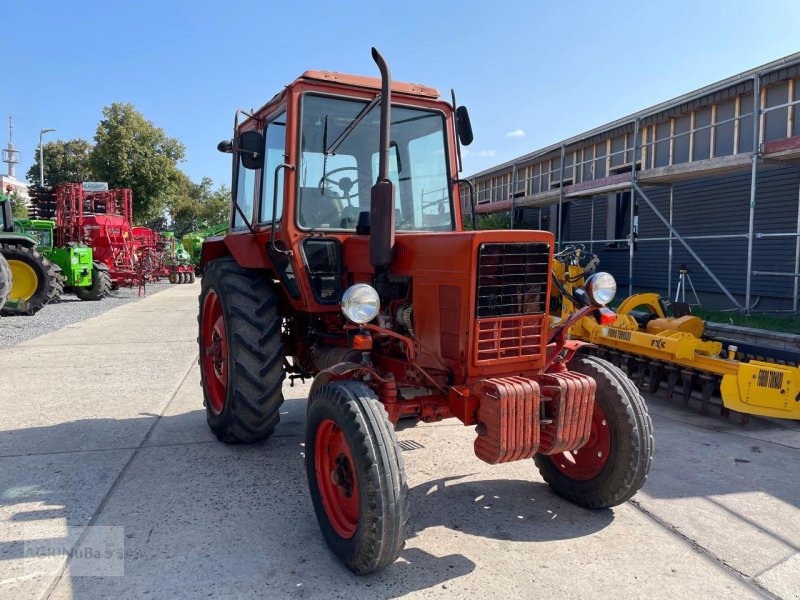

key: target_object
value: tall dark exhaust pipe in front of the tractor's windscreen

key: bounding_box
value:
[369,48,395,278]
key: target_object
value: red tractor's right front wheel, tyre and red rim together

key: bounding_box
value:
[534,356,653,508]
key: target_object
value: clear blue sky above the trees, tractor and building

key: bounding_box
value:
[0,0,800,185]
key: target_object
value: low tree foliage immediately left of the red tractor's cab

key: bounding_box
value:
[167,176,231,236]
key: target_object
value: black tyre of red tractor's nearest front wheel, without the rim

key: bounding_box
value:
[304,382,408,575]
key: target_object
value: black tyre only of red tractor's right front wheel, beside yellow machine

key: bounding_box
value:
[534,355,654,508]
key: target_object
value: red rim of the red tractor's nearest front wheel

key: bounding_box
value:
[314,419,358,538]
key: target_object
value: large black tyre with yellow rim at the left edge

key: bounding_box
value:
[0,244,64,315]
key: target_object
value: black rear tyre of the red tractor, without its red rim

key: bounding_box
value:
[197,257,285,444]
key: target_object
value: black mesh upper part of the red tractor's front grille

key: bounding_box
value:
[475,242,550,319]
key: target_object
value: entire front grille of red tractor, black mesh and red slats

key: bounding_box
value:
[475,242,550,364]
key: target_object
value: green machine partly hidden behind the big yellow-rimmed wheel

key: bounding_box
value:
[14,219,104,300]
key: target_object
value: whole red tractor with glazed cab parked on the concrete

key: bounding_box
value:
[198,49,653,573]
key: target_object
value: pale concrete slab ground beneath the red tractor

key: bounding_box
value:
[0,284,800,600]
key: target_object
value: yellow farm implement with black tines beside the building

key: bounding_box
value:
[551,247,800,419]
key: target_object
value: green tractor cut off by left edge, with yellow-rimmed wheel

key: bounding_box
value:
[0,194,64,315]
